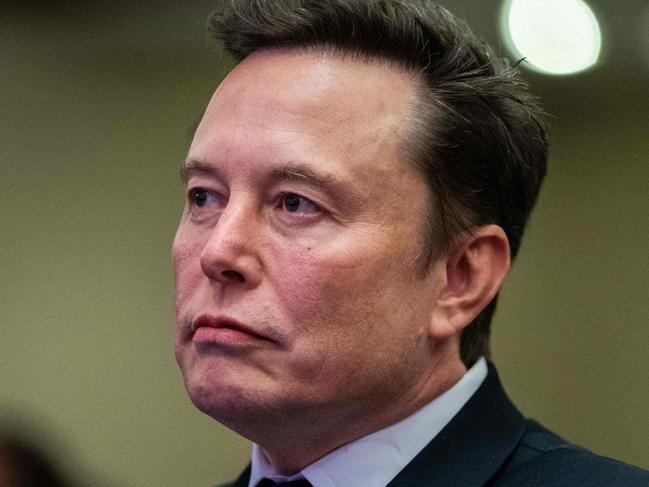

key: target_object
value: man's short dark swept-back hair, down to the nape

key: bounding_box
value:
[208,0,547,366]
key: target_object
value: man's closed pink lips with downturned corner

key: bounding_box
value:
[191,315,273,345]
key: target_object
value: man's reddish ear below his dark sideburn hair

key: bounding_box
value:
[431,225,510,340]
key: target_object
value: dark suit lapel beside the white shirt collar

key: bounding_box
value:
[388,363,525,487]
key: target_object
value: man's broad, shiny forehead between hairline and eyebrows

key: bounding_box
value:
[190,50,416,175]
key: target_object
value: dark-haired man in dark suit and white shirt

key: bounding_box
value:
[173,0,649,487]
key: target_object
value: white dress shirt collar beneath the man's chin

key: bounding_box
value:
[248,358,487,487]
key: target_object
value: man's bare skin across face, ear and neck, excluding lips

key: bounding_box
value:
[173,50,509,473]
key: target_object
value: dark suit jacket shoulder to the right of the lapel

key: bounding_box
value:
[493,421,649,487]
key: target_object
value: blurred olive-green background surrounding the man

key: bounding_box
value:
[0,0,649,487]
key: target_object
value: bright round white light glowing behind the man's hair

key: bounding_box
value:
[502,0,602,75]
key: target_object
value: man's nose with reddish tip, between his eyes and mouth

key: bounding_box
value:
[200,199,261,288]
